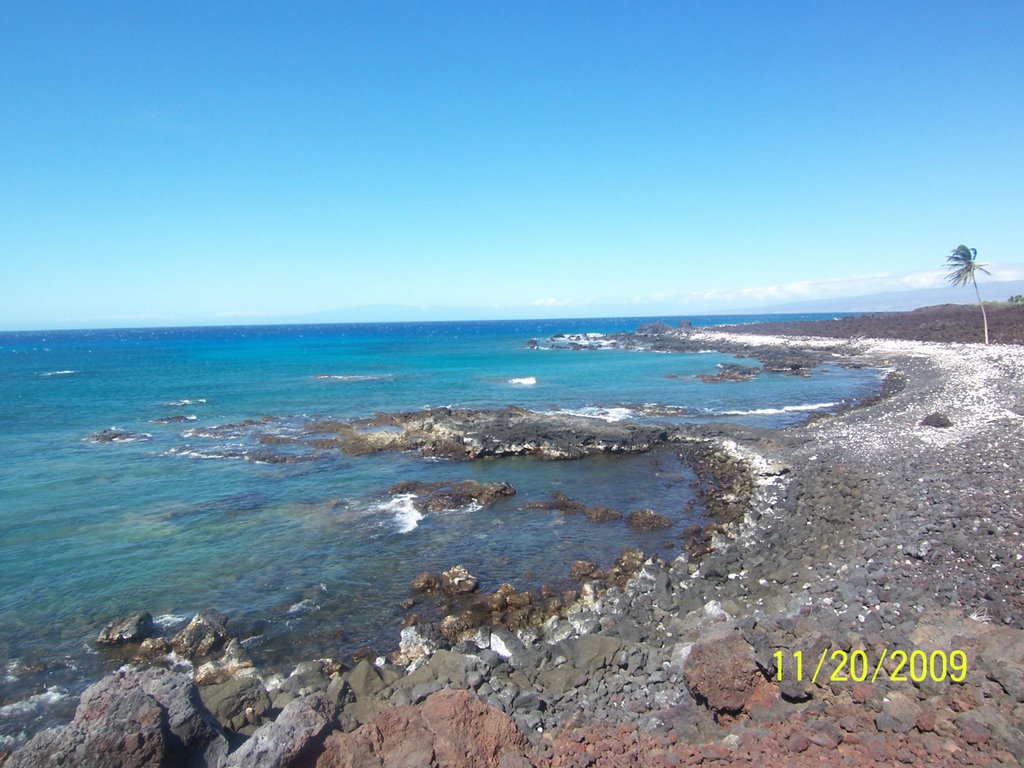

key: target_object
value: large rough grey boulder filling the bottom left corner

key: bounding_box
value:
[7,668,227,768]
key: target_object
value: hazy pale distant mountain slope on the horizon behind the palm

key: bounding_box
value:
[743,280,1024,313]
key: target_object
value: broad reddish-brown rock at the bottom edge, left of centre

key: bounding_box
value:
[316,690,529,768]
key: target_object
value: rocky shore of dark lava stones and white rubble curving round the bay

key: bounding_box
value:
[0,305,1024,768]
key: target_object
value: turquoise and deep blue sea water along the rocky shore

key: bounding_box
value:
[0,318,879,746]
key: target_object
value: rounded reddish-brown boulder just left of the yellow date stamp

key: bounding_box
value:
[683,627,764,713]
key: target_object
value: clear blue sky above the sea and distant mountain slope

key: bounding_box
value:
[0,0,1024,330]
